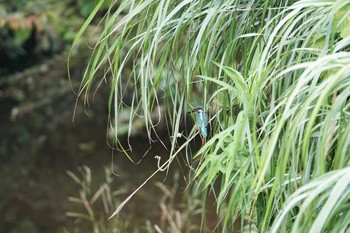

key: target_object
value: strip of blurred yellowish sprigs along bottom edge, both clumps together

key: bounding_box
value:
[65,166,208,233]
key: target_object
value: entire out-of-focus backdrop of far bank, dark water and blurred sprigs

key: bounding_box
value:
[0,0,215,233]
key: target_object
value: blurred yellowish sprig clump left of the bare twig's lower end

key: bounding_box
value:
[66,166,130,233]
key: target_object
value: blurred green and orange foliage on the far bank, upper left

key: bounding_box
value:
[0,0,111,65]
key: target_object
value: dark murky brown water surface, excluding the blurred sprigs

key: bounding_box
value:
[0,55,219,233]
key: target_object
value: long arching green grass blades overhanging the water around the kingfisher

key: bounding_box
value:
[75,0,350,232]
